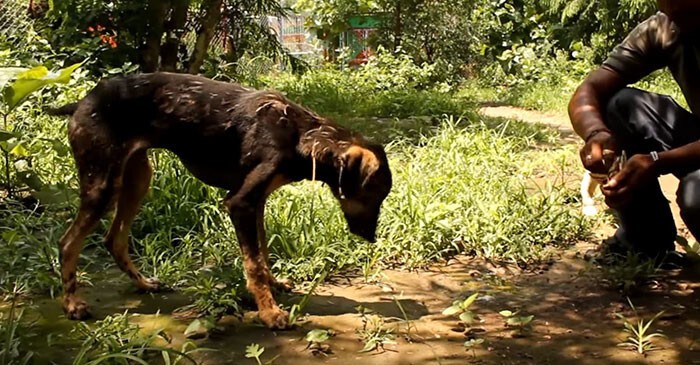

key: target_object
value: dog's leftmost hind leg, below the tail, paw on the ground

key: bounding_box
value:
[59,168,114,319]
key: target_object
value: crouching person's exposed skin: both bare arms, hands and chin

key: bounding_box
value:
[569,0,700,209]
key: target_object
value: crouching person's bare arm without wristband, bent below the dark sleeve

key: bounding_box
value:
[569,66,628,173]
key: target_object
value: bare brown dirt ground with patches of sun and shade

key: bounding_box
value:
[19,107,700,365]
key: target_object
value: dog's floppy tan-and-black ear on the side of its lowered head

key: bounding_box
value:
[340,145,380,197]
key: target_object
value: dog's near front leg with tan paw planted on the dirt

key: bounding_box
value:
[225,165,289,329]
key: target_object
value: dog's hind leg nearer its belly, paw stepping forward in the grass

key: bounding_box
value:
[105,149,159,291]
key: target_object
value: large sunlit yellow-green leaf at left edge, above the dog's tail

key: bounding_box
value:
[3,63,81,110]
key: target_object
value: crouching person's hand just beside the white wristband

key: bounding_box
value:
[601,155,656,209]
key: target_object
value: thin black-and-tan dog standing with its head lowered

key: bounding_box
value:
[48,73,392,328]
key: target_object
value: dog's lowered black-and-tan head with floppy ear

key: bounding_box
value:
[334,144,391,242]
